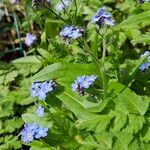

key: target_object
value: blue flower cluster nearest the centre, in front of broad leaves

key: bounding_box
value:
[71,75,97,96]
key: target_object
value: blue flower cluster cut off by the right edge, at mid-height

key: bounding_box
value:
[139,51,150,72]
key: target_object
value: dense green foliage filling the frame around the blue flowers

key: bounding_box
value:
[0,0,150,150]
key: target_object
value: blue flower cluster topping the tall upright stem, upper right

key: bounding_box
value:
[92,7,114,27]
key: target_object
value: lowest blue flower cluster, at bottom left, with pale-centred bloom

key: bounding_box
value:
[21,123,48,143]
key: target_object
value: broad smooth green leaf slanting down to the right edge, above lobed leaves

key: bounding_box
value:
[110,82,149,115]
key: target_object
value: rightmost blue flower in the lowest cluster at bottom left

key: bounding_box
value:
[35,126,48,139]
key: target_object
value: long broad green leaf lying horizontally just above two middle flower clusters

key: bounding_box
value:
[32,63,99,85]
